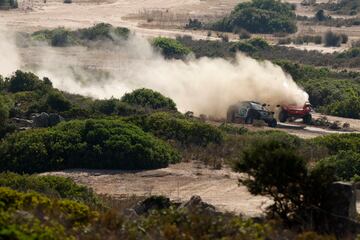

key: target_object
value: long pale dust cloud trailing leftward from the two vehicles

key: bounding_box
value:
[0,28,308,117]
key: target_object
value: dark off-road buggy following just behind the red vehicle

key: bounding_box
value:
[227,101,277,127]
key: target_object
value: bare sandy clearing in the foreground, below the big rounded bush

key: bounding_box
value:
[46,163,271,216]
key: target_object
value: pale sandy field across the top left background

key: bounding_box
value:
[0,0,239,37]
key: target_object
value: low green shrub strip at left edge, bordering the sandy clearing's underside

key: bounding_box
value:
[0,172,102,207]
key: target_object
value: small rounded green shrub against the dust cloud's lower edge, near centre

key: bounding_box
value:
[121,88,177,111]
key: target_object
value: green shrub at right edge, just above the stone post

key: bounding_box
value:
[316,151,360,181]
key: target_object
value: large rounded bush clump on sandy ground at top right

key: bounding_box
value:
[211,0,297,33]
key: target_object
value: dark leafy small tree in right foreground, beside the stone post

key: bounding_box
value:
[235,140,307,223]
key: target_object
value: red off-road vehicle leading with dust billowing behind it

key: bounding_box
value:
[279,102,312,124]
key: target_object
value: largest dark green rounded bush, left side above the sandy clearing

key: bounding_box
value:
[0,120,179,172]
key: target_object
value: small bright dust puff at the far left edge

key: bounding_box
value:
[0,26,20,75]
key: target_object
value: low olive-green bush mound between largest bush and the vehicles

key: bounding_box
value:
[126,112,223,146]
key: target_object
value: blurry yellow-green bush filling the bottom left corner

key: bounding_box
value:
[0,187,98,239]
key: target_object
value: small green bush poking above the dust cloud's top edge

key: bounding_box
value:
[152,37,191,59]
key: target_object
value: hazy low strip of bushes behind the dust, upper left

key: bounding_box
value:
[31,23,130,47]
